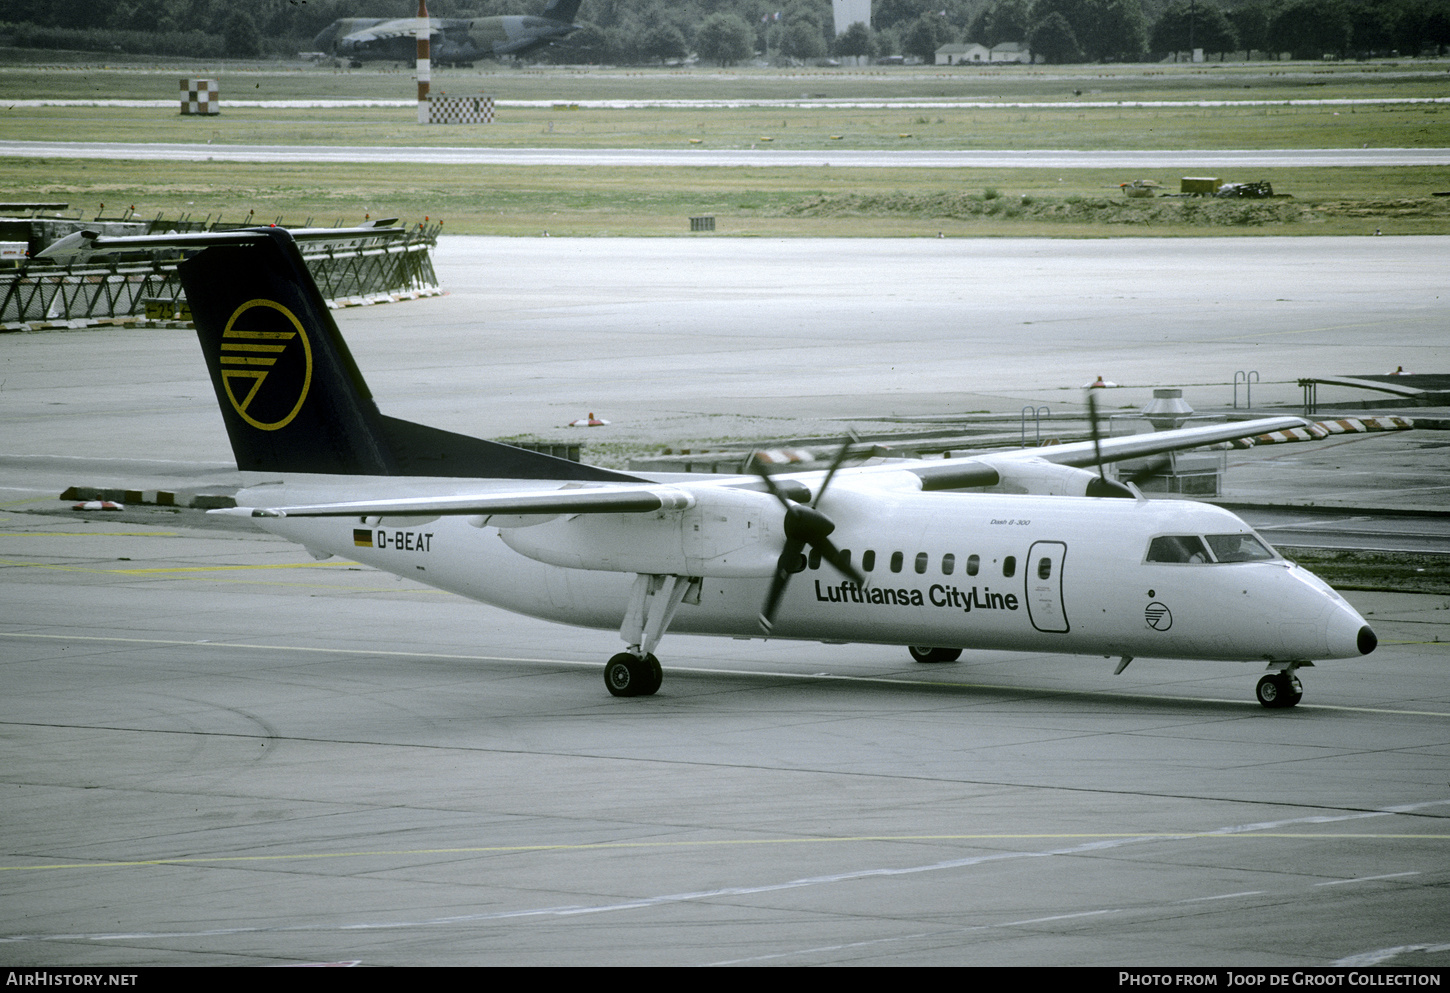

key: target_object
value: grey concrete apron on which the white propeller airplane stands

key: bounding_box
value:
[0,238,1450,968]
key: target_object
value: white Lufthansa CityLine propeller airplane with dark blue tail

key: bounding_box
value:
[113,228,1376,707]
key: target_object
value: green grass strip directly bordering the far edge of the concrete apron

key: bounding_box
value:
[0,158,1450,238]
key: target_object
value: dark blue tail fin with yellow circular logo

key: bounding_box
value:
[178,228,635,481]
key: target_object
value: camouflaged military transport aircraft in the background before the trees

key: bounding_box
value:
[312,0,580,65]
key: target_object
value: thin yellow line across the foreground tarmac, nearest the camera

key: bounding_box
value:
[0,831,1450,873]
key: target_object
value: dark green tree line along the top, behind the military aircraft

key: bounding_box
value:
[0,0,1450,65]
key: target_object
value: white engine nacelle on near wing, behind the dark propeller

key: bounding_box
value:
[499,487,784,578]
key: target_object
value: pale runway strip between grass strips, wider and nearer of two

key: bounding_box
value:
[0,141,1450,170]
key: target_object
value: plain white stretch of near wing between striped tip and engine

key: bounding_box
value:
[226,484,695,518]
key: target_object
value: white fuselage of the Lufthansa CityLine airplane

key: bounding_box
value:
[239,477,1366,661]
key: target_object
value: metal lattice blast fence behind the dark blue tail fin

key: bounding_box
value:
[0,225,439,325]
